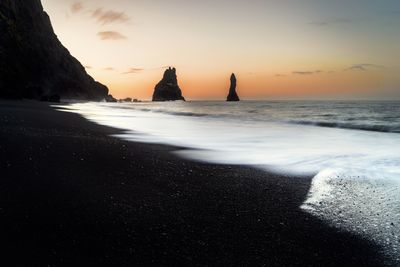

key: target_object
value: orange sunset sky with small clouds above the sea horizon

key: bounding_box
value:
[42,0,400,100]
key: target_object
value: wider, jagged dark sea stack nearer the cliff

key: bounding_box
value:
[153,67,185,101]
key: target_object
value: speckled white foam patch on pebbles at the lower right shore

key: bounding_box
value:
[301,170,400,264]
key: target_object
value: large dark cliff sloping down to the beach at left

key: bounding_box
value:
[0,0,108,101]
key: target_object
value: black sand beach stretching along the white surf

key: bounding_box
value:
[0,101,384,266]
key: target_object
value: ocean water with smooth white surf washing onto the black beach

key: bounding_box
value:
[57,101,400,264]
